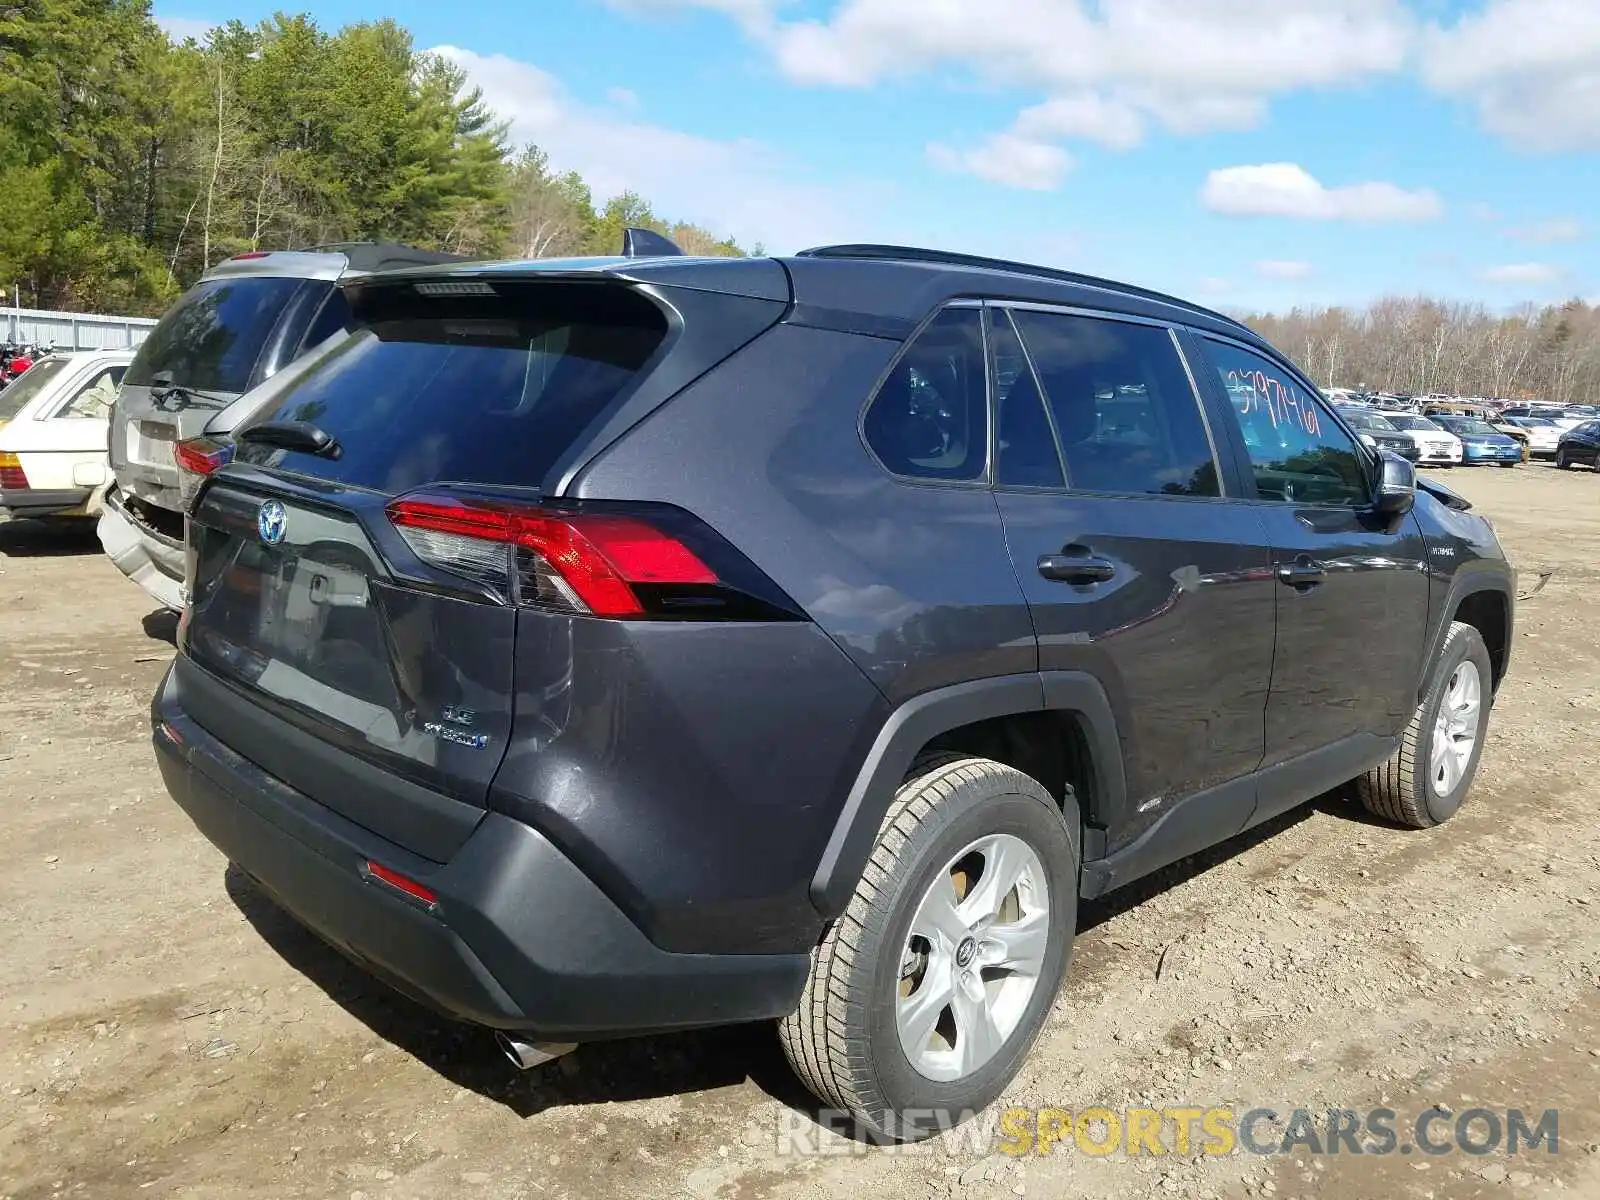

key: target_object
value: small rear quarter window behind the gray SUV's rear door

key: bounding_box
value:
[862,309,989,480]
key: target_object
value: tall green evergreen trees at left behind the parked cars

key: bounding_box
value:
[0,0,744,314]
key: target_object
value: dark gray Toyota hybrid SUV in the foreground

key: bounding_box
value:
[154,246,1512,1138]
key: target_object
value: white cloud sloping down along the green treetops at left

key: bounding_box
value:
[434,46,896,253]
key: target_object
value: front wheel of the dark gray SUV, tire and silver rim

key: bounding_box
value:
[1355,621,1494,829]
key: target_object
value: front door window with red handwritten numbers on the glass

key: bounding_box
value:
[1206,338,1368,506]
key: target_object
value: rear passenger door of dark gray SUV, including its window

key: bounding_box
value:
[989,306,1274,858]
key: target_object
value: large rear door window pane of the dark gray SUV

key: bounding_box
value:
[1013,310,1222,496]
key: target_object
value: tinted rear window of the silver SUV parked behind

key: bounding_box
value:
[125,275,304,392]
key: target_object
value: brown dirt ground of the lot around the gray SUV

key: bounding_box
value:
[0,466,1600,1200]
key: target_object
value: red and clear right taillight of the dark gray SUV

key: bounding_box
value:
[387,494,723,618]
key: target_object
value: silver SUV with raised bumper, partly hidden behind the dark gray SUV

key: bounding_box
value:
[99,242,461,610]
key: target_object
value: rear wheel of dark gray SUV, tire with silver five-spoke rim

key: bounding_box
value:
[779,755,1080,1141]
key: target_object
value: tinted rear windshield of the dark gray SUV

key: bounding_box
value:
[238,283,667,494]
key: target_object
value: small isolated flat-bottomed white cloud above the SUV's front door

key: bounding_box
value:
[1200,163,1445,222]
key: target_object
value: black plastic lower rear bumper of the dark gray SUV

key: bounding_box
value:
[152,674,810,1042]
